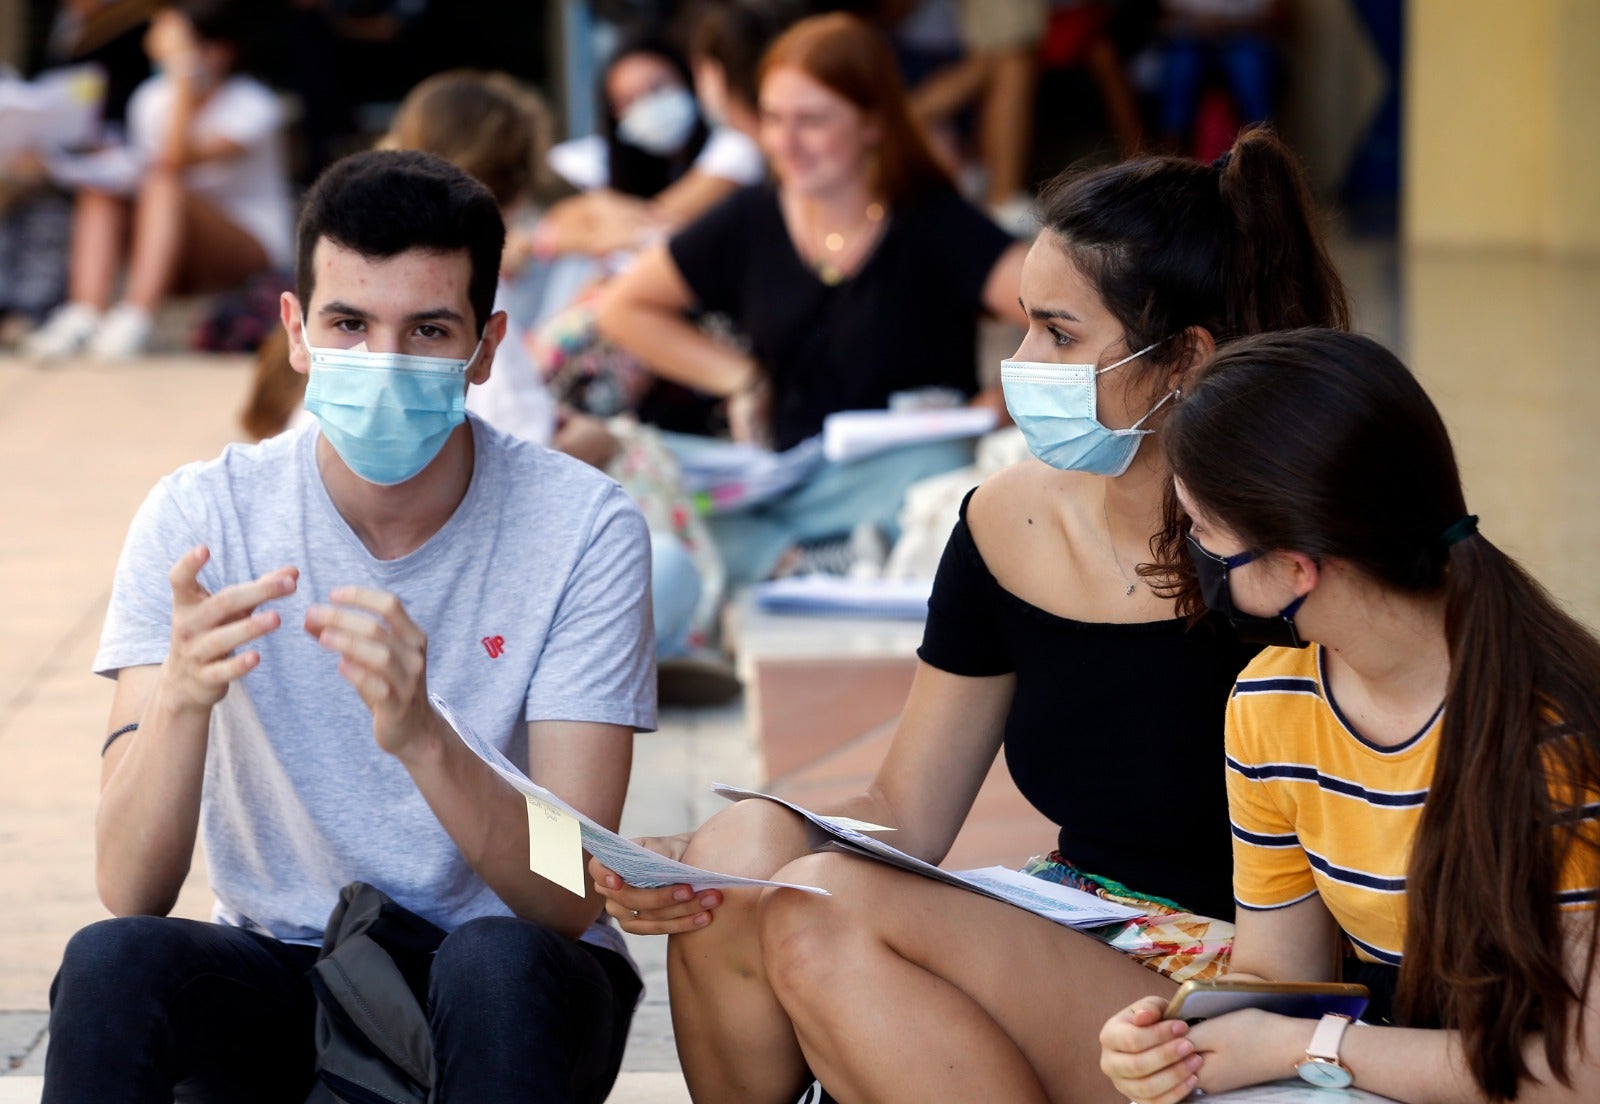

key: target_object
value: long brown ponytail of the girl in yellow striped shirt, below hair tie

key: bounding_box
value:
[1397,536,1600,1099]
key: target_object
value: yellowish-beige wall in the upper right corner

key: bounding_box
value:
[1402,0,1600,254]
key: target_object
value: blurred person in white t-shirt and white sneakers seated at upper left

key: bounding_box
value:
[24,0,294,358]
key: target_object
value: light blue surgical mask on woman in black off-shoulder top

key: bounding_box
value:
[1000,341,1178,475]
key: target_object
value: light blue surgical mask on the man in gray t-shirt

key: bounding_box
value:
[302,323,483,486]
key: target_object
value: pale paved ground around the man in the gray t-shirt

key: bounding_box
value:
[0,357,748,1104]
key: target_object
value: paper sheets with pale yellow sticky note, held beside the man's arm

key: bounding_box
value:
[441,694,827,896]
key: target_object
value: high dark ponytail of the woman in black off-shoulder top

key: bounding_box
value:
[1213,126,1350,334]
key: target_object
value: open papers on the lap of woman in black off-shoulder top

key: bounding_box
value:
[712,786,1144,928]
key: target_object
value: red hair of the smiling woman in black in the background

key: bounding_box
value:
[760,11,950,203]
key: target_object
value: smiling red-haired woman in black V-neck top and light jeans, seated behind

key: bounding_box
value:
[598,13,1024,582]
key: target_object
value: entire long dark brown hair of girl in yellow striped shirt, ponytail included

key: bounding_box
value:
[1154,330,1600,1099]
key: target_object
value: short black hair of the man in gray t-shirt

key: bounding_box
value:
[294,149,506,333]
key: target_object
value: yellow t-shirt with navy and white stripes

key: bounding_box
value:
[1226,645,1597,965]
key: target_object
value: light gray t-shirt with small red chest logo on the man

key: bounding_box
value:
[94,416,656,947]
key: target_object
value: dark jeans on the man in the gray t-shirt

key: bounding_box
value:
[43,917,640,1104]
